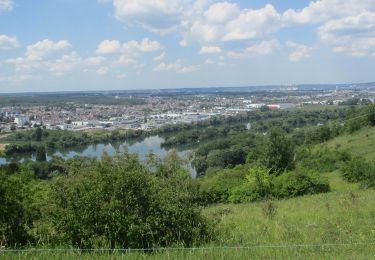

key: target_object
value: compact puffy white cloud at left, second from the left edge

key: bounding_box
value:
[25,39,72,61]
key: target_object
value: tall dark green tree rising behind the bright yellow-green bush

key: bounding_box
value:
[263,128,294,174]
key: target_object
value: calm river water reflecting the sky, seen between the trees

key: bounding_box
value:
[0,136,196,177]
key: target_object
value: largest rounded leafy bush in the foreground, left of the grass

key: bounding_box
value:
[46,154,209,248]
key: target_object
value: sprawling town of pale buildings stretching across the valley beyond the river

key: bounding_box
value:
[0,84,375,132]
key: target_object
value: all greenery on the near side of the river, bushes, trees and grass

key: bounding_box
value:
[0,106,375,259]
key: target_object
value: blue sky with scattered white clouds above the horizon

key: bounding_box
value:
[0,0,375,93]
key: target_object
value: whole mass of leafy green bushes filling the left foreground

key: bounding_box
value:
[0,153,213,248]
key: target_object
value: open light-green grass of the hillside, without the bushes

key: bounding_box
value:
[0,128,375,259]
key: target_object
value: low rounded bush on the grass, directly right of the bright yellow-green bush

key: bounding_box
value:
[273,169,330,198]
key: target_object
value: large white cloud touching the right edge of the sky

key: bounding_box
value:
[319,11,375,56]
